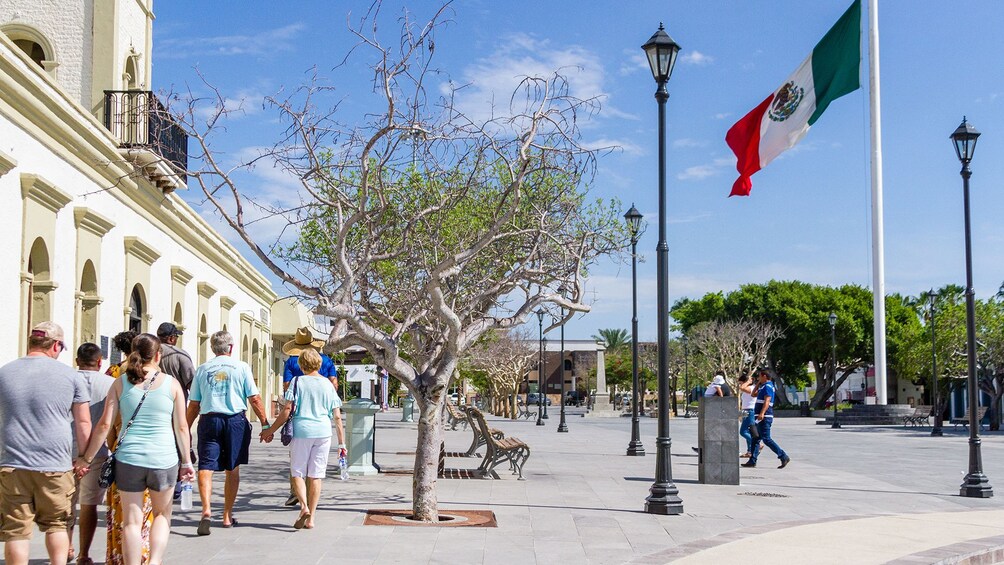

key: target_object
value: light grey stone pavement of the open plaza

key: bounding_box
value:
[5,406,1004,565]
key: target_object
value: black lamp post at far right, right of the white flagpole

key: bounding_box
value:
[952,116,994,499]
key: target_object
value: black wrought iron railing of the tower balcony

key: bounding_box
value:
[104,90,188,183]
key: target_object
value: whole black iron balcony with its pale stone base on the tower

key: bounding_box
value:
[104,90,188,192]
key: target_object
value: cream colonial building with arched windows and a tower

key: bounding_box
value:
[0,0,277,411]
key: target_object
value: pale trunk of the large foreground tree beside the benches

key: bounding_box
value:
[412,394,446,523]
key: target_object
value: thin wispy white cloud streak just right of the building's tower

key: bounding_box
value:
[156,23,306,59]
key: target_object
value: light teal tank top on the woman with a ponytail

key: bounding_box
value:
[115,372,179,469]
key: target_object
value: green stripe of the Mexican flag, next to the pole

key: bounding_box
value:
[809,0,861,125]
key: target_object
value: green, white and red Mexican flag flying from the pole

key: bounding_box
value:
[725,0,861,197]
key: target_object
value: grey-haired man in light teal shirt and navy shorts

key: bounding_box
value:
[188,331,268,536]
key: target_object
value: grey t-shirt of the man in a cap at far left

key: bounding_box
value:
[0,356,90,473]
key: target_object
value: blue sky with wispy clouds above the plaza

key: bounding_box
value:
[153,0,1004,340]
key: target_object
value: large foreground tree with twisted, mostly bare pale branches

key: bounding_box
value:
[160,3,626,521]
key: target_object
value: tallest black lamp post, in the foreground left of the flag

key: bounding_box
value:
[642,24,684,515]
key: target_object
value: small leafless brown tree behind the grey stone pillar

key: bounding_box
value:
[688,318,784,390]
